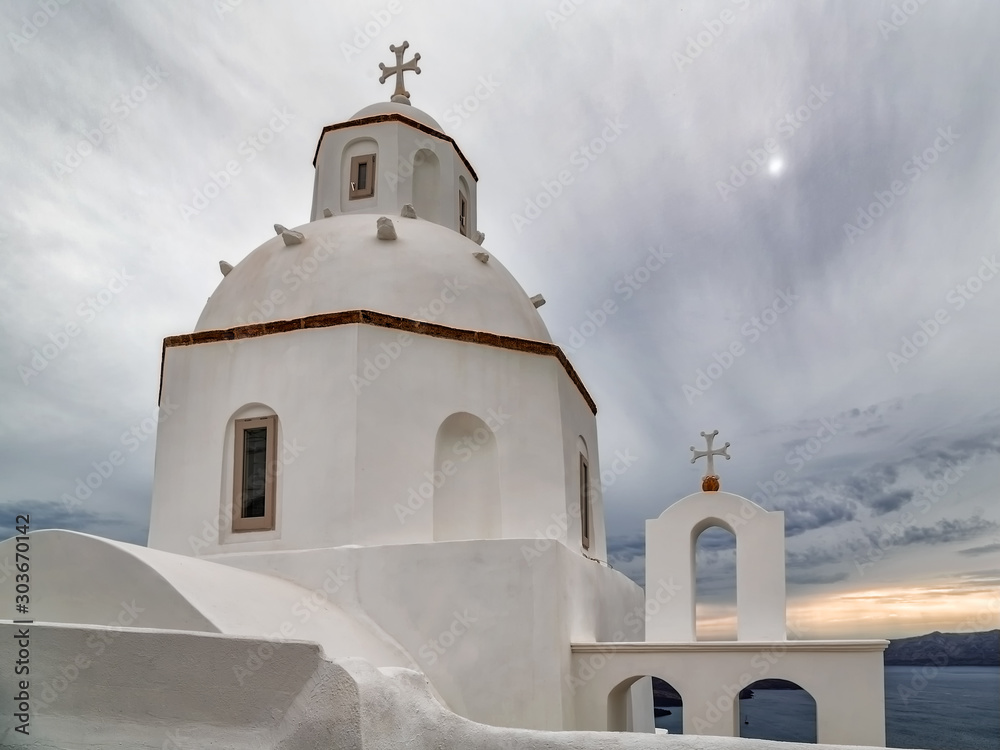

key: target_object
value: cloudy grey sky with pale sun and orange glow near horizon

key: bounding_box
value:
[0,0,1000,637]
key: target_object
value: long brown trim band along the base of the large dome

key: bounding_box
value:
[160,310,597,414]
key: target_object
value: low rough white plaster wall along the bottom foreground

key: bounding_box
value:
[0,623,892,750]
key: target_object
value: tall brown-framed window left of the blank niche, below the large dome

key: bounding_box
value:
[233,415,278,531]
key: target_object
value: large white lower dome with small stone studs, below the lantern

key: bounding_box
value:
[196,214,552,342]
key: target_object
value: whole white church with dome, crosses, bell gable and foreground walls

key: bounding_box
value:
[0,47,887,750]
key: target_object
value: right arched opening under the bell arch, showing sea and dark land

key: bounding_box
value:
[737,679,816,742]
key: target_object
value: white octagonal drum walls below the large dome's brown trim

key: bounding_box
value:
[149,325,605,556]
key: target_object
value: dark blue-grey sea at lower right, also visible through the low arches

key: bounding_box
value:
[656,667,1000,750]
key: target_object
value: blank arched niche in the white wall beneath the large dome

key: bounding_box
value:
[433,412,501,542]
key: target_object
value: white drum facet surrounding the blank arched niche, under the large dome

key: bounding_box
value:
[353,326,593,544]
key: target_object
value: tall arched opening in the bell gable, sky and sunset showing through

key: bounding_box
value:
[692,524,737,641]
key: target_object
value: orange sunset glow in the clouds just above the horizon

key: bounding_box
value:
[698,584,1000,640]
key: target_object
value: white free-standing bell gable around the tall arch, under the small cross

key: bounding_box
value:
[646,492,786,642]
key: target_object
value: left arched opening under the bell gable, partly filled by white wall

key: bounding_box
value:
[608,675,684,734]
